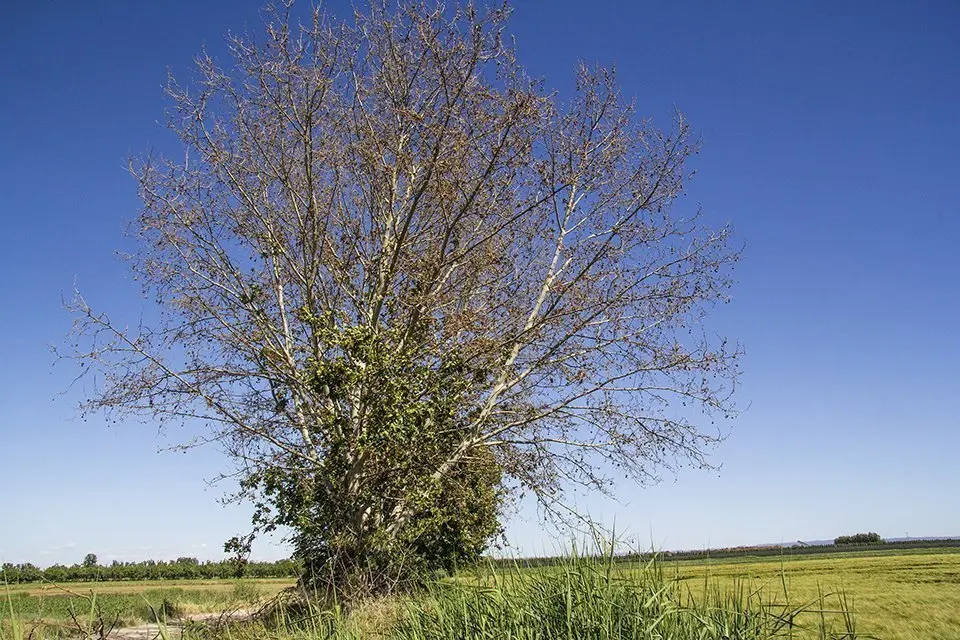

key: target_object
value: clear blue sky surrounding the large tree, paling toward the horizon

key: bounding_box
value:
[0,0,960,564]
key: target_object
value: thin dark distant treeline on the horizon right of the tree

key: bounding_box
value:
[491,538,960,567]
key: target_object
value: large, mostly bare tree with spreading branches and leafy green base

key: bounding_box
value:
[67,4,738,593]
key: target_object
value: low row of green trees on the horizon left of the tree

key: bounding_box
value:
[0,558,300,584]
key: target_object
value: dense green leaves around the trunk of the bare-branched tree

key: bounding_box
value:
[245,318,501,595]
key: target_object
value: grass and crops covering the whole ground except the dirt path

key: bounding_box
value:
[0,548,960,640]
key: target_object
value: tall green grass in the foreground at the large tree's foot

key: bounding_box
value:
[178,555,865,640]
